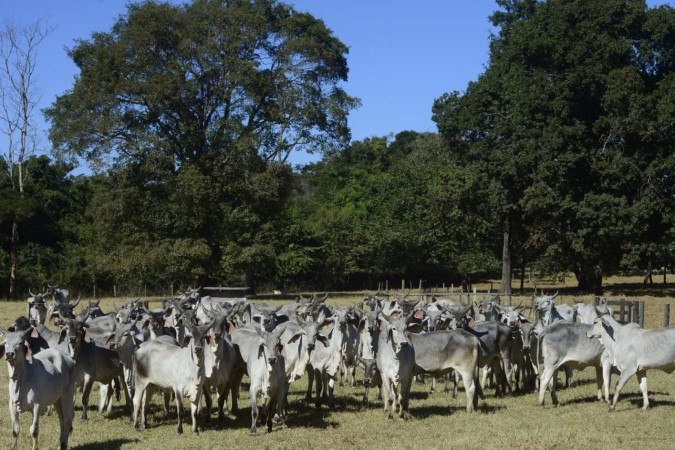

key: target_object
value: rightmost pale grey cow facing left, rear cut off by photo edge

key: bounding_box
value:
[587,315,675,410]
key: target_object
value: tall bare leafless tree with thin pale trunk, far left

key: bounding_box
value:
[0,21,51,298]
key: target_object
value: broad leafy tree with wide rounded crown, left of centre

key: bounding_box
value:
[46,0,357,283]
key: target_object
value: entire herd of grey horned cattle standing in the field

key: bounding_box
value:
[0,286,675,448]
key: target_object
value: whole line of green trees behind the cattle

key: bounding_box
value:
[0,0,675,294]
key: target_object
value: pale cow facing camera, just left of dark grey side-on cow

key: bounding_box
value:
[375,314,419,420]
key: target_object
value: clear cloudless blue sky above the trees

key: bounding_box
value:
[0,0,671,170]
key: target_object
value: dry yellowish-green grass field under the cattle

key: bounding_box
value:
[0,278,675,449]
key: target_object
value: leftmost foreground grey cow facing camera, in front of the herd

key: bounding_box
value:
[0,327,75,450]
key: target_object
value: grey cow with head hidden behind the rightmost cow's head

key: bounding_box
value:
[539,321,609,406]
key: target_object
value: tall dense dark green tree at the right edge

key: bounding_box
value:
[434,0,673,292]
